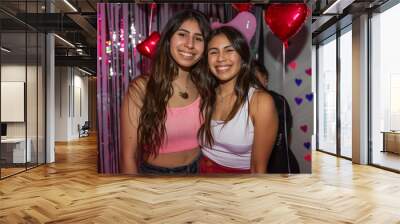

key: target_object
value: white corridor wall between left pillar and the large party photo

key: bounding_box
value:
[55,67,88,141]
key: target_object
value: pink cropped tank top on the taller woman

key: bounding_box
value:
[159,97,202,153]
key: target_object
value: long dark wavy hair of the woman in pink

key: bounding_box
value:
[136,9,210,164]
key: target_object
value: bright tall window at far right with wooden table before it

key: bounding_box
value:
[370,1,400,170]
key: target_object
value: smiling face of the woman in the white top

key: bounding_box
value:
[207,34,242,83]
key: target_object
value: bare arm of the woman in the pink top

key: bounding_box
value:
[120,77,145,174]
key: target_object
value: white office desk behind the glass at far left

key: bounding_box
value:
[1,138,32,163]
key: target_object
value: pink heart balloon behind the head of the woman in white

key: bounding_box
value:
[211,12,257,44]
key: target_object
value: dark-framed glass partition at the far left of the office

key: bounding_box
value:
[0,1,46,178]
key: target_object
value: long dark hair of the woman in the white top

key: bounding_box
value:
[198,26,265,147]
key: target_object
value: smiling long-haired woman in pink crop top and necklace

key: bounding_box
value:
[120,10,210,174]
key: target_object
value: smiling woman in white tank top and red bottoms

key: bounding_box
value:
[199,26,278,173]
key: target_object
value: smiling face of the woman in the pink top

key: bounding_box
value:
[170,19,204,70]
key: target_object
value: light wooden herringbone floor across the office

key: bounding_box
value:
[0,134,400,224]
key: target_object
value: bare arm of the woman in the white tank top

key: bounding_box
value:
[250,91,278,173]
